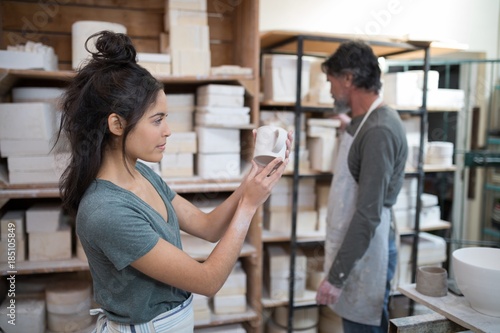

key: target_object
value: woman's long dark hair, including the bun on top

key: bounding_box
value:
[58,31,163,213]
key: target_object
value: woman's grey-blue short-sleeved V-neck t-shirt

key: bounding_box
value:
[76,162,190,324]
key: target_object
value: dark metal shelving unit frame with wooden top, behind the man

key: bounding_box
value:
[261,31,430,332]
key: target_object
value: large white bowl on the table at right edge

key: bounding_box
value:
[452,247,500,317]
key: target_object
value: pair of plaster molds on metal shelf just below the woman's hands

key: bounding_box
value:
[264,177,318,236]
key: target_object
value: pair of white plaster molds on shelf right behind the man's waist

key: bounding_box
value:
[392,178,441,230]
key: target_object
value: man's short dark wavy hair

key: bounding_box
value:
[321,41,382,92]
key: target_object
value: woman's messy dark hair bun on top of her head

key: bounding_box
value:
[85,30,137,64]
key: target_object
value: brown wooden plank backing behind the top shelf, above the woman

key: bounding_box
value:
[0,0,254,69]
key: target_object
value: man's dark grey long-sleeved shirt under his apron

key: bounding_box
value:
[328,106,408,287]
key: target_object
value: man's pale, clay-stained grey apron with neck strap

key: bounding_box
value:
[324,97,391,326]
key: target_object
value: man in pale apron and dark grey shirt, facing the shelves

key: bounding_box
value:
[316,41,408,333]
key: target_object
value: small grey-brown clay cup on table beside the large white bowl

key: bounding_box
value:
[416,266,448,297]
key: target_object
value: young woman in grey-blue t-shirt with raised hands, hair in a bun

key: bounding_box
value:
[60,31,292,333]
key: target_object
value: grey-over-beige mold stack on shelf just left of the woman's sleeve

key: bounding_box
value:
[26,203,72,261]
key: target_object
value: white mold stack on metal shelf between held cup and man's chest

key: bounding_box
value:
[307,118,340,172]
